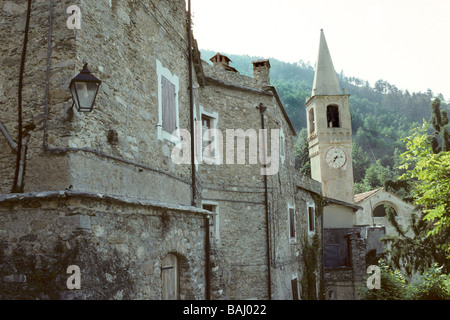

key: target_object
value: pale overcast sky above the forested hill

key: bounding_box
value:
[191,0,450,101]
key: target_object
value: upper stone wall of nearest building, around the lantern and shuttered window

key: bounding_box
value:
[0,0,191,204]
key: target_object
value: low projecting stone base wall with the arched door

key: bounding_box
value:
[0,192,205,300]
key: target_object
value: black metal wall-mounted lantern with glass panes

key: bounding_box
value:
[69,63,102,112]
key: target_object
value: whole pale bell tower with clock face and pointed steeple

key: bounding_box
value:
[305,30,354,204]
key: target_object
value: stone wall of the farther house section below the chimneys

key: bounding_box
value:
[195,56,321,299]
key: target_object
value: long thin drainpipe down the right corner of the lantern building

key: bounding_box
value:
[188,0,197,207]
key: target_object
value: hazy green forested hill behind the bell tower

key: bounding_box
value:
[201,50,450,191]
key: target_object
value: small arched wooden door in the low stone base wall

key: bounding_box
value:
[161,254,180,300]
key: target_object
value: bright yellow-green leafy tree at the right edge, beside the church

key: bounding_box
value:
[383,119,450,275]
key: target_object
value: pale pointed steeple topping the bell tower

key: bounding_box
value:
[312,29,342,96]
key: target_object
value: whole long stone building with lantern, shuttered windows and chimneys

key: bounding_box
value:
[0,0,323,300]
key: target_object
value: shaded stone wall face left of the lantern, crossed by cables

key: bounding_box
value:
[0,0,75,193]
